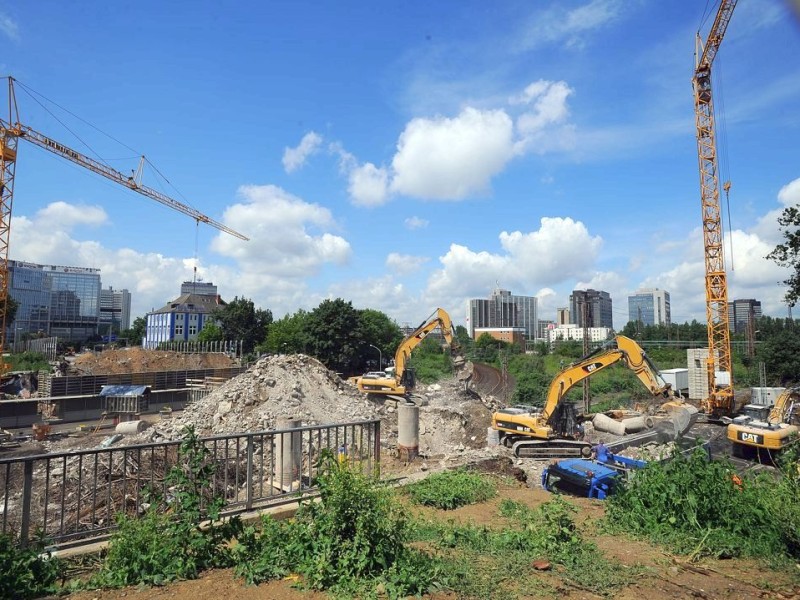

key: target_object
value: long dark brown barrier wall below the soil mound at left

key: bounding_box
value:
[39,366,247,398]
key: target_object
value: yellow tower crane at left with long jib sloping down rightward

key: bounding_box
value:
[0,77,248,374]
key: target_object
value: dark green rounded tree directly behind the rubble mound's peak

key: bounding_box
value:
[303,298,364,374]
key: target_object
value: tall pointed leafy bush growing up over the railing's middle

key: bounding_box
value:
[90,428,241,587]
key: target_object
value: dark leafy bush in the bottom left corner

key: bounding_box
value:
[0,535,63,600]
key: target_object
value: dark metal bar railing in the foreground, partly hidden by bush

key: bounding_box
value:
[0,420,381,547]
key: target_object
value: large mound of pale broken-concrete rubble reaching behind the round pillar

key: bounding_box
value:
[136,354,491,455]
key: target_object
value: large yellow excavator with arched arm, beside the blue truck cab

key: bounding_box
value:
[492,335,684,458]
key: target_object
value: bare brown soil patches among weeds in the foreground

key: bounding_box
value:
[68,474,800,600]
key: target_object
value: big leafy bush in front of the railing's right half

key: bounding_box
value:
[235,452,440,598]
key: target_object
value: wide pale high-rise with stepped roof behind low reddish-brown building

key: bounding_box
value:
[467,288,538,340]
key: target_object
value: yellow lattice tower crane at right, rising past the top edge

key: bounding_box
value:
[692,0,737,418]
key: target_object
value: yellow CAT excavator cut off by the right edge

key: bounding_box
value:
[728,386,800,461]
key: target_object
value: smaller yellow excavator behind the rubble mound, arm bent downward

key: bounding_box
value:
[355,308,464,400]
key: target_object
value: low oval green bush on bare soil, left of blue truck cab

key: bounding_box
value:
[406,469,497,510]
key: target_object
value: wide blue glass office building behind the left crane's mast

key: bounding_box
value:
[6,260,100,341]
